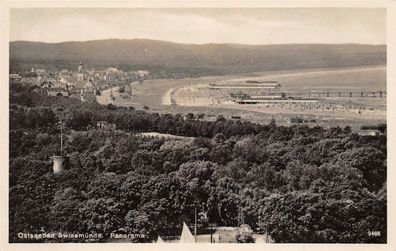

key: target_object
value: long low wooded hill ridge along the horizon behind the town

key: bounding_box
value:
[10,39,386,73]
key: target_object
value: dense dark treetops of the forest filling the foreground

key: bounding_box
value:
[9,86,387,243]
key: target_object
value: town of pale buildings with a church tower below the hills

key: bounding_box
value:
[10,63,149,101]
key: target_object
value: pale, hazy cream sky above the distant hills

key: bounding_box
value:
[10,8,386,44]
